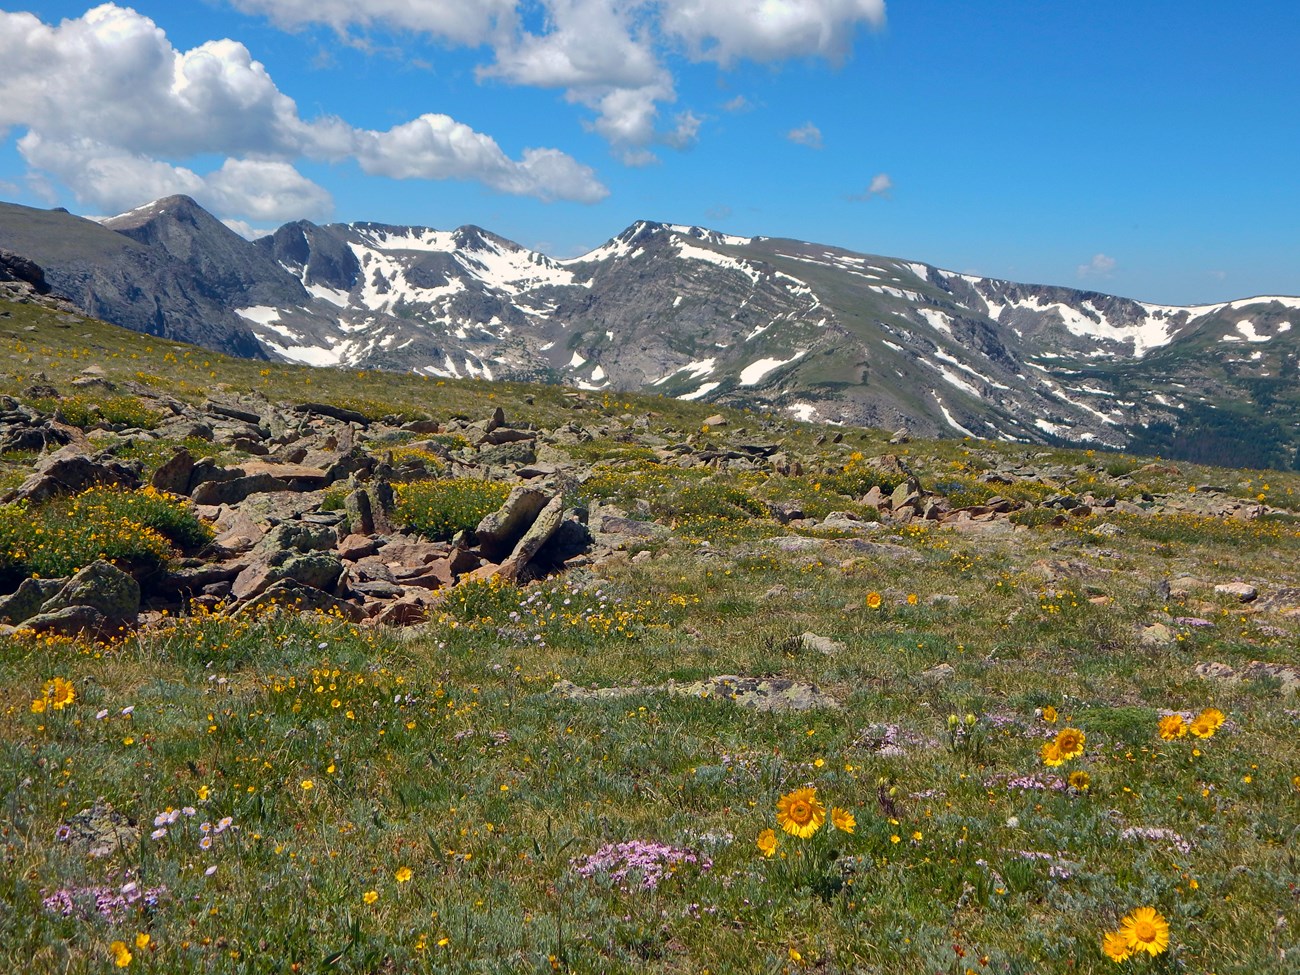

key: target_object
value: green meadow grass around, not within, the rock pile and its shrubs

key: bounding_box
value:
[0,301,1300,975]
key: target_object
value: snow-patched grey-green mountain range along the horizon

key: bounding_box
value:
[0,196,1300,468]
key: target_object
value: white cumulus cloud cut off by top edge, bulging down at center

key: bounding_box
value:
[231,0,885,165]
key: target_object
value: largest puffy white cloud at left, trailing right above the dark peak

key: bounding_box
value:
[0,3,606,220]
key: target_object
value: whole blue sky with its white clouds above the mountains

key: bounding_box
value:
[0,0,1300,304]
